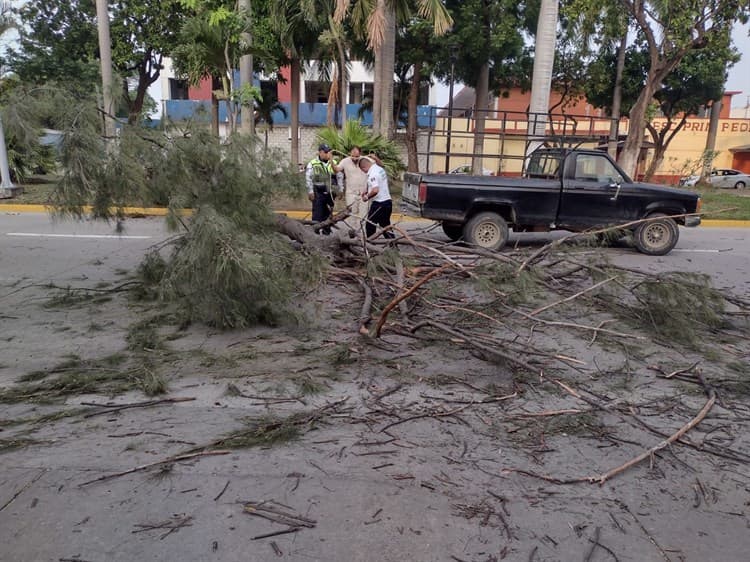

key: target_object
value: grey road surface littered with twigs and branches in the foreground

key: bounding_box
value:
[0,228,750,562]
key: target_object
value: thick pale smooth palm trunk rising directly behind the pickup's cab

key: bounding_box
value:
[526,0,558,156]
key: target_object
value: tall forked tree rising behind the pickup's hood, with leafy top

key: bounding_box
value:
[620,0,750,176]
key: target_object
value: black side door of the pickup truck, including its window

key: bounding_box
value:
[557,153,624,227]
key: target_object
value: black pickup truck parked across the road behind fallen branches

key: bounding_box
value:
[402,148,701,255]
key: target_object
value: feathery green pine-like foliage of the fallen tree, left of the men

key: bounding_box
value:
[50,103,322,328]
